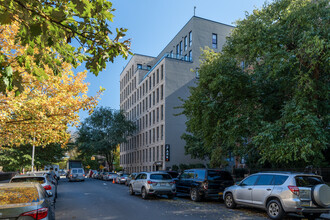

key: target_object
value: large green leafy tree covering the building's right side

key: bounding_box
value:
[182,0,330,166]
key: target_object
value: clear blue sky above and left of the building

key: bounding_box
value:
[76,0,265,125]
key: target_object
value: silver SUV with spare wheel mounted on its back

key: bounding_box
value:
[223,172,330,219]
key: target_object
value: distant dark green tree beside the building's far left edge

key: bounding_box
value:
[76,107,135,170]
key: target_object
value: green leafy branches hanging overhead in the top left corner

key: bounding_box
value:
[0,0,130,92]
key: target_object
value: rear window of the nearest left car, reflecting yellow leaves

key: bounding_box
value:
[0,187,39,206]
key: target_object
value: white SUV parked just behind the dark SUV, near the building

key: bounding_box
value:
[129,172,176,199]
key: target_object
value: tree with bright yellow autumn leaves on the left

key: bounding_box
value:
[0,24,101,146]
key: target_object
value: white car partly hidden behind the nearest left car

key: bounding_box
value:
[9,174,57,203]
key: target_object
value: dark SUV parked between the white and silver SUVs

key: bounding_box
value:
[176,169,234,202]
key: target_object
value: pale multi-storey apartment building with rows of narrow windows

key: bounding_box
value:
[120,16,233,172]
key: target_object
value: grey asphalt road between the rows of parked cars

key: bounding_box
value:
[56,179,328,220]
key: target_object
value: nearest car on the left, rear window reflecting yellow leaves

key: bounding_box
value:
[0,182,55,220]
